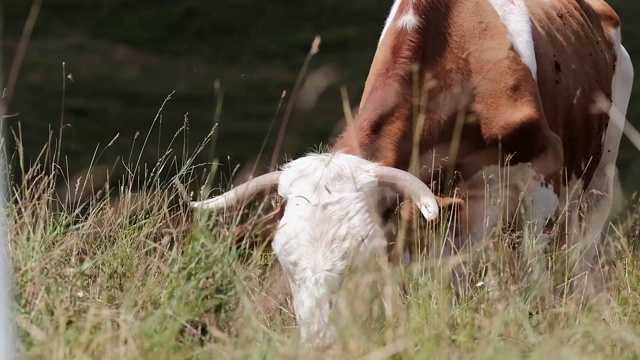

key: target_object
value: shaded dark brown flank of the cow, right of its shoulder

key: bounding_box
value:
[527,0,620,184]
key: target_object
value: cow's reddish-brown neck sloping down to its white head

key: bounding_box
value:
[333,0,450,168]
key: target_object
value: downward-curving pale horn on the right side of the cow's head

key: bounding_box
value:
[373,166,439,220]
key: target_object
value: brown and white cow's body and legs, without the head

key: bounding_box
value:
[334,0,633,288]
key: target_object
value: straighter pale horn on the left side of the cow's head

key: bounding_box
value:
[191,170,282,210]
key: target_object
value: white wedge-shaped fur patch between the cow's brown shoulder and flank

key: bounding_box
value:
[489,0,538,79]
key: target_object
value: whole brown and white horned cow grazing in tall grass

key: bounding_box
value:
[193,0,634,343]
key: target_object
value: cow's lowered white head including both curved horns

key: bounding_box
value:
[191,153,438,344]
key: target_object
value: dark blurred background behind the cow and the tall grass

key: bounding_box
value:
[2,0,640,198]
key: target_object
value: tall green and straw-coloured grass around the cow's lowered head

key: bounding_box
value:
[9,88,640,359]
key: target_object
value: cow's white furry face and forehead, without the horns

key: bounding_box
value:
[272,154,386,344]
